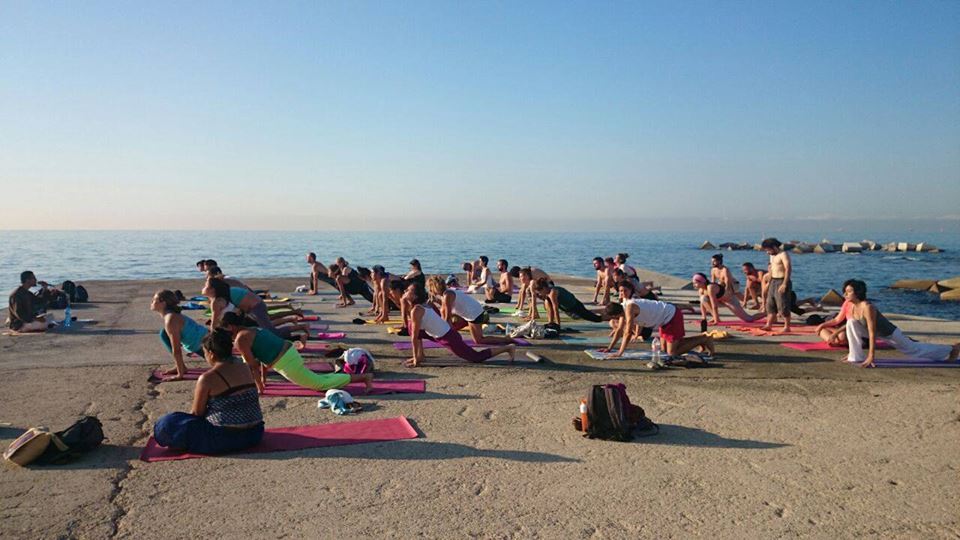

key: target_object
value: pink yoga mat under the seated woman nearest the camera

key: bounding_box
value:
[140,416,417,463]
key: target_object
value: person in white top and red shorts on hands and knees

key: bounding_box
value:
[600,282,716,358]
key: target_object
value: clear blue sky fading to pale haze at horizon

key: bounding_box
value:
[0,0,960,230]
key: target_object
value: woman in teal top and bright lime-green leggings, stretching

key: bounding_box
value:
[223,313,373,393]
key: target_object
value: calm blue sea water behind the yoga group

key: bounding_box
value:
[0,231,960,320]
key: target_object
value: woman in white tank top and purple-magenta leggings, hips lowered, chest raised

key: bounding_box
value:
[403,283,517,367]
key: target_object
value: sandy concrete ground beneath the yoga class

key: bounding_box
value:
[0,275,960,538]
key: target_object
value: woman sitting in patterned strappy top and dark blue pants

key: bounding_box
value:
[153,329,263,454]
